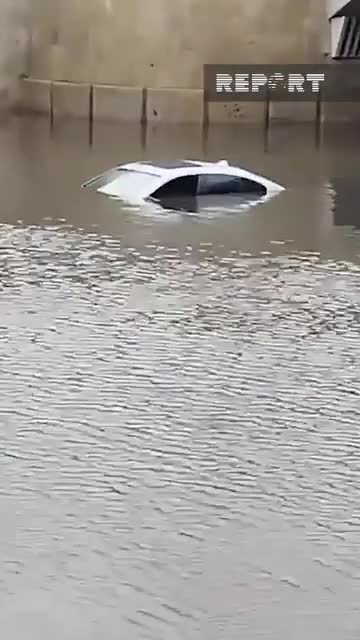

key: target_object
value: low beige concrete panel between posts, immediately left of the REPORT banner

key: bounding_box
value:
[146,89,204,124]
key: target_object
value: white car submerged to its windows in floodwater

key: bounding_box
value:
[82,160,284,210]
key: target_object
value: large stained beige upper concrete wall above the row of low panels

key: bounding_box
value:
[27,0,327,89]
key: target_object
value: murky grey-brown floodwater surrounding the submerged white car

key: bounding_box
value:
[0,119,360,640]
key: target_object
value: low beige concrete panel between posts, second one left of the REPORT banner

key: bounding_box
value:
[93,85,144,122]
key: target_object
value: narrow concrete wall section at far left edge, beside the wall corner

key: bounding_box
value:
[0,0,28,109]
